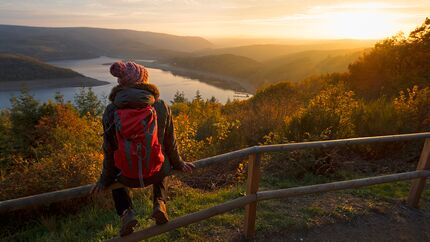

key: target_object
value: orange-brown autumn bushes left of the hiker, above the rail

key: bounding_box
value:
[0,95,103,200]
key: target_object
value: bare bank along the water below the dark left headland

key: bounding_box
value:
[0,76,110,92]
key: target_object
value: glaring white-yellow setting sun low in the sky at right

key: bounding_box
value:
[327,9,399,39]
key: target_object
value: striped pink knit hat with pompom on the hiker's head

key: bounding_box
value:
[110,61,148,85]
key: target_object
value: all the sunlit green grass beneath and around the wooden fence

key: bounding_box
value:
[0,172,430,242]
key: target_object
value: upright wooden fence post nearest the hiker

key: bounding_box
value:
[244,153,261,239]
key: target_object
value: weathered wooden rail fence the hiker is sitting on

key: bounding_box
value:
[0,132,430,242]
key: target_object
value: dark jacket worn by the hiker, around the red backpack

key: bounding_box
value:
[99,84,184,187]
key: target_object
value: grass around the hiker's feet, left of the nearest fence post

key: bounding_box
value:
[0,182,243,241]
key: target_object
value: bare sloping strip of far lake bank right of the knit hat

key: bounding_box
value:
[137,61,257,95]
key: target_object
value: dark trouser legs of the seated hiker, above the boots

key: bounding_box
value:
[112,178,167,216]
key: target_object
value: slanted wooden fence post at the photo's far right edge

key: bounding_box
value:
[408,139,430,208]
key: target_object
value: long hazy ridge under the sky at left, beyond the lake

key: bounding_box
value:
[0,25,213,60]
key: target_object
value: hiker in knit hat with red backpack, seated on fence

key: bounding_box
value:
[91,61,194,236]
